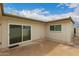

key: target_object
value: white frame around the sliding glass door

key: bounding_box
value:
[8,23,32,46]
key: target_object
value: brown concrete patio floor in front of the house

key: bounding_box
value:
[0,40,79,56]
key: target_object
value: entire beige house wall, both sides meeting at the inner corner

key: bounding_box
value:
[0,16,74,48]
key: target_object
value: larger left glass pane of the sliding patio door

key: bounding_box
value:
[10,25,22,44]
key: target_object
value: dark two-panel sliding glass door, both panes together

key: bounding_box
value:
[9,25,31,44]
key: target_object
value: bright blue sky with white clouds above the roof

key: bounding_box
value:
[4,3,79,27]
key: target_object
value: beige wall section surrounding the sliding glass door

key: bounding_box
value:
[0,17,45,48]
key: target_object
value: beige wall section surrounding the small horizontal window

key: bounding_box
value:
[46,20,74,43]
